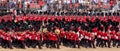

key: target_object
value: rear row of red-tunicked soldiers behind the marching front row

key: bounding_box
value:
[0,15,120,32]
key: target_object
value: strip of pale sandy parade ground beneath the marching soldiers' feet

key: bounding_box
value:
[0,46,120,51]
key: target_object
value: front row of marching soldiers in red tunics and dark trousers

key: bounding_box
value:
[0,28,120,49]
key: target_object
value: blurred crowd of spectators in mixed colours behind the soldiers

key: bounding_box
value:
[0,0,119,11]
